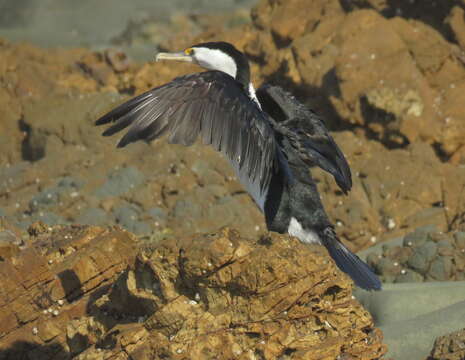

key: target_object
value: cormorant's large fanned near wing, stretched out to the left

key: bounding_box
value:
[96,71,278,198]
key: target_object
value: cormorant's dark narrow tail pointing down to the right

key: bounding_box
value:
[320,227,381,290]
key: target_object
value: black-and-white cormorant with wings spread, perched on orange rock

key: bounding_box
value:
[96,41,381,290]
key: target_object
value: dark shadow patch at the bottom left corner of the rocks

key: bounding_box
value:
[0,341,71,360]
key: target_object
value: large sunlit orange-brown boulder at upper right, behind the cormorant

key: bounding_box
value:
[246,0,465,156]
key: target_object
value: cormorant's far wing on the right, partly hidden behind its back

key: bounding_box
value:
[257,85,352,193]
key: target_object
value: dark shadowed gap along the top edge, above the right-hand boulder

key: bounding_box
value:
[340,0,465,42]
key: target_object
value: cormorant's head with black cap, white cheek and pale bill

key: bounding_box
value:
[156,41,250,86]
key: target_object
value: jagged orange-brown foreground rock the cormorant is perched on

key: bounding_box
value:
[0,225,386,359]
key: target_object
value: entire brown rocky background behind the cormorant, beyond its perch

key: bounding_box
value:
[0,0,465,250]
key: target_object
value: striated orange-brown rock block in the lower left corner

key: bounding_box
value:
[0,223,135,359]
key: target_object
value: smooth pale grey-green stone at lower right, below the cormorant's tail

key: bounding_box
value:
[354,281,465,360]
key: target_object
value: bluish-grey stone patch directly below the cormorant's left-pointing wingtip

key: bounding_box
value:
[94,167,145,199]
